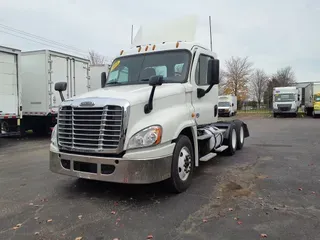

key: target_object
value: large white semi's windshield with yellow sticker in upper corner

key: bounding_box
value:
[106,50,191,85]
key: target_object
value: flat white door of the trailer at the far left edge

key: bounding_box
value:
[0,52,19,115]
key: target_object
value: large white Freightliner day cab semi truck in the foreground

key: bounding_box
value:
[50,18,249,193]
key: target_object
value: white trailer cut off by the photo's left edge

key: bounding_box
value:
[0,46,22,137]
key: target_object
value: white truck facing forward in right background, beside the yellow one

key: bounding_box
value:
[273,86,301,117]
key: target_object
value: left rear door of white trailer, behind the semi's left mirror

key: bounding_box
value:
[49,54,71,112]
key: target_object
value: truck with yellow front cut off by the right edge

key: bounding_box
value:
[305,82,320,117]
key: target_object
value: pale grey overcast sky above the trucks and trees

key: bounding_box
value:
[0,0,320,81]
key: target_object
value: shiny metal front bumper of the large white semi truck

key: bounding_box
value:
[50,143,174,184]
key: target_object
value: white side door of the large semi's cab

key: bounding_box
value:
[191,48,218,125]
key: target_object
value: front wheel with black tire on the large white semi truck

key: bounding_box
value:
[167,135,194,193]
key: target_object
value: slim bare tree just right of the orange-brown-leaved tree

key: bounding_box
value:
[250,69,268,108]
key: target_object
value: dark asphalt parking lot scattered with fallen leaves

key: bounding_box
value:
[0,118,320,240]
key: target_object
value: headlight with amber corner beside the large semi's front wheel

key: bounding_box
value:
[128,125,162,149]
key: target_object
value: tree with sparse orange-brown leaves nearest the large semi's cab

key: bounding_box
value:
[224,57,253,101]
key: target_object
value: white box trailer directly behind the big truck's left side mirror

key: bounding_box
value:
[21,50,91,134]
